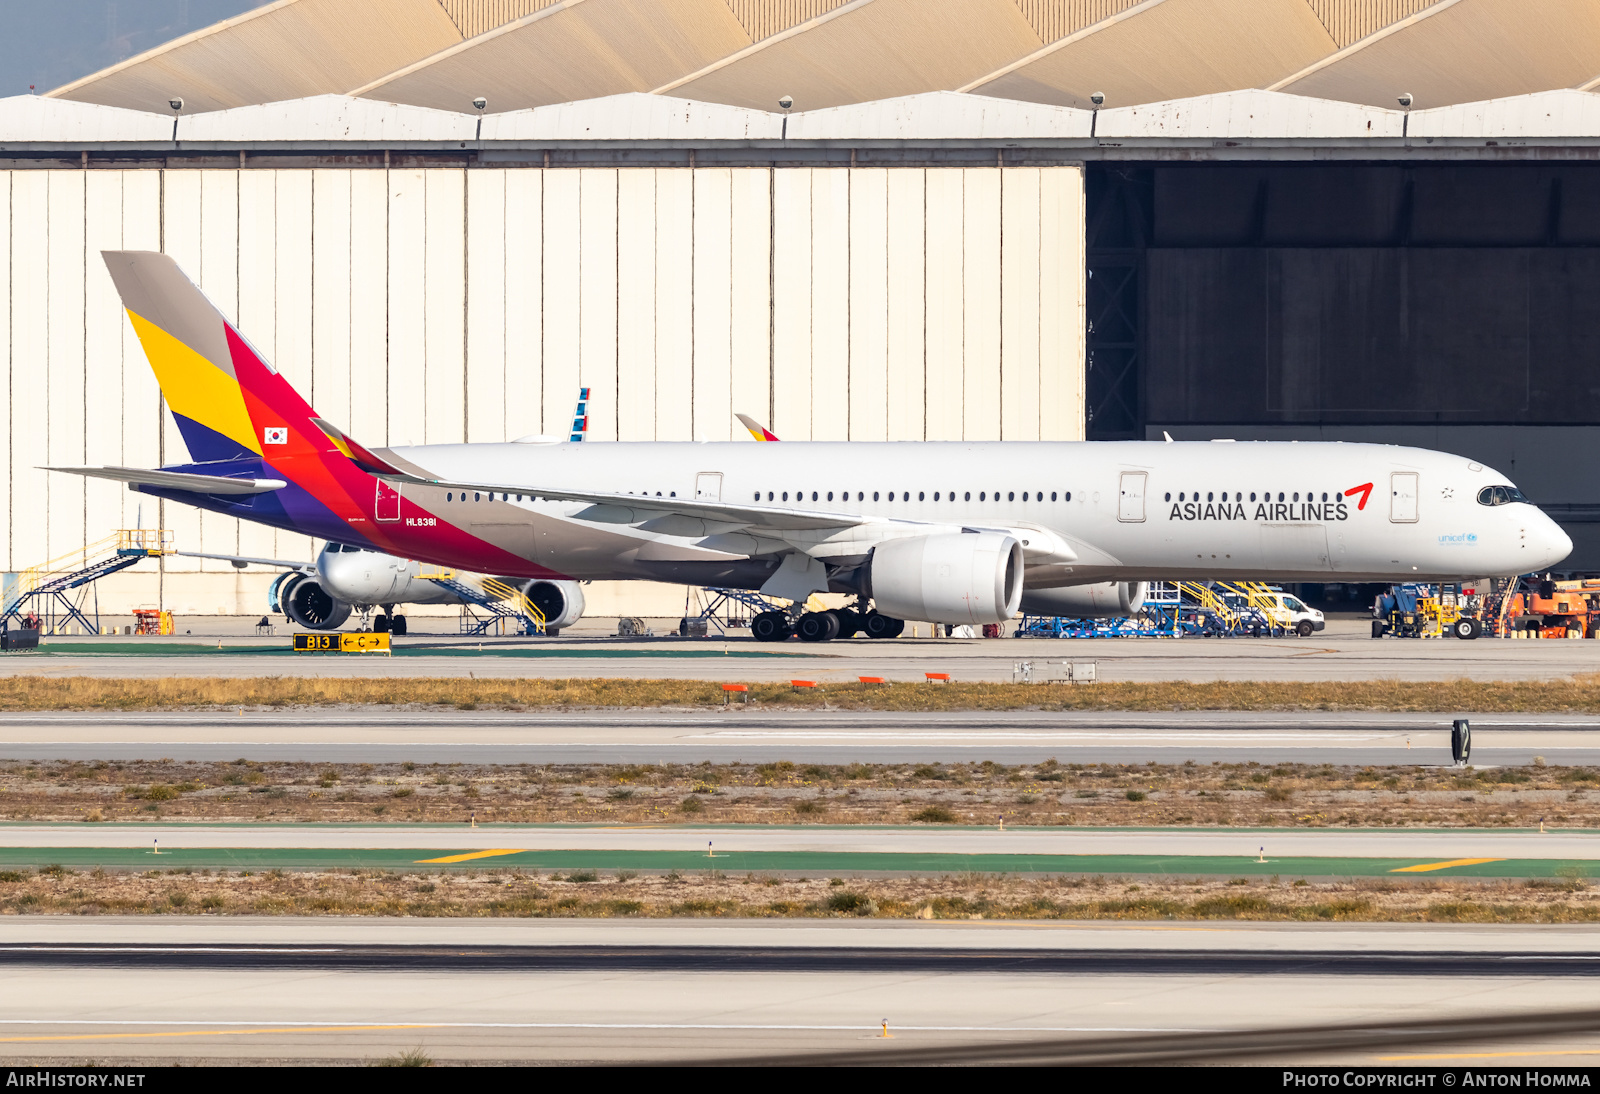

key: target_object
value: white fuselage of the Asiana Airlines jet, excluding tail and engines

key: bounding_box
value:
[380,441,1571,587]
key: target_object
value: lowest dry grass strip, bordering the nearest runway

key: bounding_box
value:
[0,868,1600,923]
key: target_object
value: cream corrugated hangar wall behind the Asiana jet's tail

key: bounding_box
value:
[0,166,1083,614]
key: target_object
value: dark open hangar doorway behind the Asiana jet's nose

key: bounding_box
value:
[1085,163,1600,571]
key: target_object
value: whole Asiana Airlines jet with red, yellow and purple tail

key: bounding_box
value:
[51,251,1571,641]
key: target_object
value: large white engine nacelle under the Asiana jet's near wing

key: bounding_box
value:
[867,533,1022,624]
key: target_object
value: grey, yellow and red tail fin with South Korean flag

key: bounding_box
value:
[101,251,326,462]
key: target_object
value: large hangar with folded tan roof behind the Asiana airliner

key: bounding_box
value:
[0,0,1600,614]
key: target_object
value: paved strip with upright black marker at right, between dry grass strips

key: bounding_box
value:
[0,709,1600,766]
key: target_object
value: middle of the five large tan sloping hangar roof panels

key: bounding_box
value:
[656,0,1043,110]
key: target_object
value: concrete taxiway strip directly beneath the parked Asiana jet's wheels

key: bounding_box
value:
[18,621,1600,683]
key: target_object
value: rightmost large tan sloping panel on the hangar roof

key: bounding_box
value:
[1274,0,1600,109]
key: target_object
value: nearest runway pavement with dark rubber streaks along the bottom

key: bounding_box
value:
[0,916,1600,1067]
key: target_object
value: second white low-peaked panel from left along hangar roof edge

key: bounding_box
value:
[178,94,478,141]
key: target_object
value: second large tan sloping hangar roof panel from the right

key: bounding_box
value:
[962,0,1338,107]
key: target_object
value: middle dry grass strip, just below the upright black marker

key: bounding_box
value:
[0,758,1600,828]
